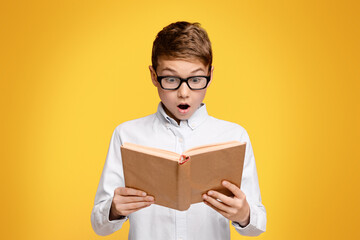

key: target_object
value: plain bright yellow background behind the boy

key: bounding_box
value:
[0,0,360,240]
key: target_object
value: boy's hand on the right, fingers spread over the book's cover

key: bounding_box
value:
[203,181,250,227]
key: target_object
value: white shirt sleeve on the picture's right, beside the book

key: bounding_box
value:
[232,130,266,236]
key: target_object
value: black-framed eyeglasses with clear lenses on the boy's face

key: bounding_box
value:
[157,76,210,90]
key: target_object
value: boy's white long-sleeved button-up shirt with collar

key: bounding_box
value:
[91,102,266,240]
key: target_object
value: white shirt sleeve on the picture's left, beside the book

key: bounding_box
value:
[91,128,128,236]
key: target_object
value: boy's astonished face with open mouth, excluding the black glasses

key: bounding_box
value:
[149,58,214,124]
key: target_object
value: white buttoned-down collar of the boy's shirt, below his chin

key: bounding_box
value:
[156,102,209,129]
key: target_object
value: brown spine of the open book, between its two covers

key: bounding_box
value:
[177,158,191,211]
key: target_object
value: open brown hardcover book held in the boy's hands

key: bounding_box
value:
[120,141,246,211]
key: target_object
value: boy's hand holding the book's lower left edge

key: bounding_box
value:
[109,187,154,221]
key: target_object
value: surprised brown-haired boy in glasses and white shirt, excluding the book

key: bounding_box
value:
[91,22,266,240]
